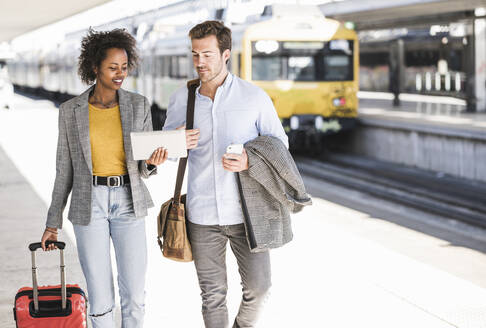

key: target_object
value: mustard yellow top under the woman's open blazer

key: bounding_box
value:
[89,104,127,177]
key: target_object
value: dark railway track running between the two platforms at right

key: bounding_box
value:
[296,154,486,228]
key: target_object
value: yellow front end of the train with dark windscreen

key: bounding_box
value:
[232,8,359,148]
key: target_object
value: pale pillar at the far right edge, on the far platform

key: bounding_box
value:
[474,18,486,112]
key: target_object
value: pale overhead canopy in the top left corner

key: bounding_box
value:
[0,0,111,42]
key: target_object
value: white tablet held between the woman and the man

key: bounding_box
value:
[130,130,187,161]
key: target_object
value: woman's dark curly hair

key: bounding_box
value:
[78,28,138,84]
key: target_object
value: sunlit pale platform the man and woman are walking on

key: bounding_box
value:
[0,96,486,328]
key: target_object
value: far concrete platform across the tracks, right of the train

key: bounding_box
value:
[342,92,486,183]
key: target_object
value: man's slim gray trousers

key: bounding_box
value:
[187,222,271,328]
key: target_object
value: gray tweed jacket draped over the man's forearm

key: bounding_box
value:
[238,136,312,252]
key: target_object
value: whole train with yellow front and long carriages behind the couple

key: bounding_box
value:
[5,2,359,148]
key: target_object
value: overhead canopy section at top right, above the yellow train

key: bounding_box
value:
[320,0,486,30]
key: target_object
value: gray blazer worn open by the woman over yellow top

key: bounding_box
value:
[46,87,157,228]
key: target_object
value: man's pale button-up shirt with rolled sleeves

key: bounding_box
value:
[164,73,288,225]
